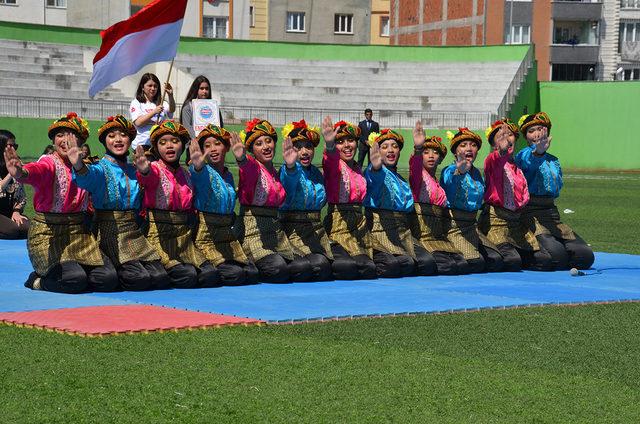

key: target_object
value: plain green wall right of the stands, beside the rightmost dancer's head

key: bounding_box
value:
[540,81,640,170]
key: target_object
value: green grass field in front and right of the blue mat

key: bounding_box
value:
[5,173,640,423]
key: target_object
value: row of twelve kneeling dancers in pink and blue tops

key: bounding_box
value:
[5,112,594,293]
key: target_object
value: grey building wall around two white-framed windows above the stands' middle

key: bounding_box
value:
[269,0,371,44]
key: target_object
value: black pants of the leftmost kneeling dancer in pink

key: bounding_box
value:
[37,255,118,294]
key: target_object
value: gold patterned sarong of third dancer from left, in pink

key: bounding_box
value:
[147,209,207,269]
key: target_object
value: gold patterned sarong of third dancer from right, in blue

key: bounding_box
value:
[447,209,498,260]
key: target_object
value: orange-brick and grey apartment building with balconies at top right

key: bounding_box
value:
[390,0,640,81]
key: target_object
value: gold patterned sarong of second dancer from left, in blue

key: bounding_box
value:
[93,209,160,267]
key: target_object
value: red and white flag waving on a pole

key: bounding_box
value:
[89,0,187,97]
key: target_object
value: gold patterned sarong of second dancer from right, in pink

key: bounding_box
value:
[478,204,540,252]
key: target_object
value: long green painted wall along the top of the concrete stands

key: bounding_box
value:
[0,21,529,62]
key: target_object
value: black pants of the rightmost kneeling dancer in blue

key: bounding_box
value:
[536,234,595,270]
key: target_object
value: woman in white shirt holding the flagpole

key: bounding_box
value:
[129,72,176,150]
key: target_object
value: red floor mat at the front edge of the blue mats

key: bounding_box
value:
[0,305,263,336]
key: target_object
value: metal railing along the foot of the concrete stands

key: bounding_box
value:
[0,95,496,129]
